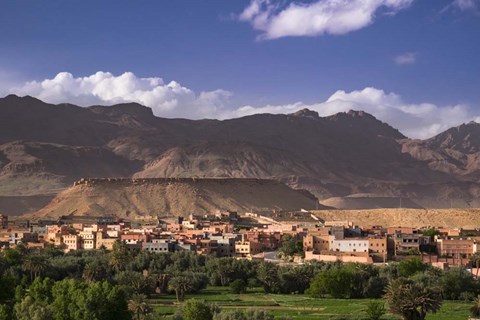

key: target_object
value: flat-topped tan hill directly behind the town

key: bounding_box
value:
[34,178,316,219]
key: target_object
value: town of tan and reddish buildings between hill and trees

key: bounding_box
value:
[0,211,480,275]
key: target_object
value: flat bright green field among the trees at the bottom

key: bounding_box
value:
[150,287,472,320]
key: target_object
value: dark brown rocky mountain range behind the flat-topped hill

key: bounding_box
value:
[0,95,480,214]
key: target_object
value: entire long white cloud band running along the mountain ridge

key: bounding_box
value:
[5,72,480,138]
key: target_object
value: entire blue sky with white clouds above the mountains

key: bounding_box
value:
[0,0,480,138]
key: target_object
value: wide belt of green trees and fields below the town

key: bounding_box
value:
[0,243,480,320]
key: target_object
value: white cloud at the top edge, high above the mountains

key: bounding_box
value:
[239,0,413,39]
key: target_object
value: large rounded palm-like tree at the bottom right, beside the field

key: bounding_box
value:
[385,278,442,320]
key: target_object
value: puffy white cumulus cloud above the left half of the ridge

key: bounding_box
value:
[10,72,231,119]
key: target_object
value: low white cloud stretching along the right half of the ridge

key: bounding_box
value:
[225,87,480,139]
